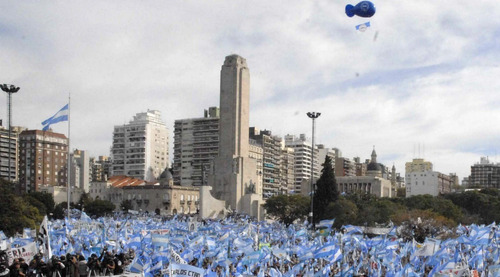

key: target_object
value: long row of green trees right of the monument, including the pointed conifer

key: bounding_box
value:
[264,157,500,233]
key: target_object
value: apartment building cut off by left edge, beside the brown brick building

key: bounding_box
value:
[0,123,26,182]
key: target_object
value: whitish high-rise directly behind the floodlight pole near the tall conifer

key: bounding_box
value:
[285,134,320,193]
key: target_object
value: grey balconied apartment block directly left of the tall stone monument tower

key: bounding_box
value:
[173,107,220,186]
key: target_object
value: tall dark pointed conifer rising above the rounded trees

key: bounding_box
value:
[313,156,339,222]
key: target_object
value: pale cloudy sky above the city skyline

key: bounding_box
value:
[0,0,500,180]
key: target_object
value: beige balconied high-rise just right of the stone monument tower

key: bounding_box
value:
[250,127,286,198]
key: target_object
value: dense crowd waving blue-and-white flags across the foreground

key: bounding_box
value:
[0,210,500,277]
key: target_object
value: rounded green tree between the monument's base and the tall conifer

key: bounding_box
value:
[264,194,311,226]
